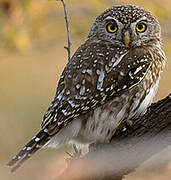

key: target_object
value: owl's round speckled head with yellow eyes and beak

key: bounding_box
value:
[88,5,161,47]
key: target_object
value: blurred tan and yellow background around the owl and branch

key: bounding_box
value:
[0,0,171,180]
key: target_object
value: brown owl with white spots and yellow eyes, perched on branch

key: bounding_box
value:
[8,5,166,171]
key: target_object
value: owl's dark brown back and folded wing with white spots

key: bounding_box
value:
[42,43,153,135]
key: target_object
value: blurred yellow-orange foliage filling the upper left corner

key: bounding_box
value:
[0,0,53,52]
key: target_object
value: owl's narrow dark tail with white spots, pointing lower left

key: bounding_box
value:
[7,127,51,172]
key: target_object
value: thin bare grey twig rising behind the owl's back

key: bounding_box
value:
[57,0,71,61]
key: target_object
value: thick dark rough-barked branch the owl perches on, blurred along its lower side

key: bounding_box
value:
[59,94,171,180]
